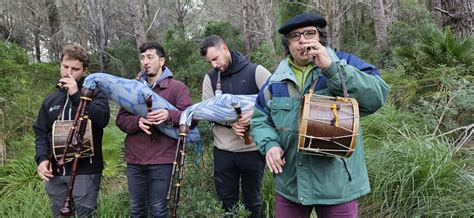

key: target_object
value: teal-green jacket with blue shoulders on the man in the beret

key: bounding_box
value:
[251,48,389,205]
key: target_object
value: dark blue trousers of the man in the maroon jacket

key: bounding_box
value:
[127,163,173,217]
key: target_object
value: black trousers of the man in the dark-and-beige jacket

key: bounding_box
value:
[214,147,265,217]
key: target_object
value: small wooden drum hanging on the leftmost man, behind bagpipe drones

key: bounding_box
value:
[51,120,94,162]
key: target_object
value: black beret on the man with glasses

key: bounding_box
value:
[278,13,327,35]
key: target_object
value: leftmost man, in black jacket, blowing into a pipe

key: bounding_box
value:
[33,45,110,217]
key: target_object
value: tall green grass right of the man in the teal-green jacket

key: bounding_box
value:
[361,107,474,217]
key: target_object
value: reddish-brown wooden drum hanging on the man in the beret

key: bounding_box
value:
[298,94,359,157]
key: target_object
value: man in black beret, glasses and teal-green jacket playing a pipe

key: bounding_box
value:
[251,14,389,217]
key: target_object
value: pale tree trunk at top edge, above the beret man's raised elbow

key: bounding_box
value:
[372,0,388,53]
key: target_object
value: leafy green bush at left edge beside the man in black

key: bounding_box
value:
[0,43,58,155]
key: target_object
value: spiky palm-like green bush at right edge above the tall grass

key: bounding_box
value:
[385,28,474,134]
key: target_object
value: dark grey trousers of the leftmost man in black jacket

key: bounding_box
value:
[44,174,101,217]
